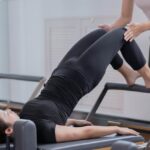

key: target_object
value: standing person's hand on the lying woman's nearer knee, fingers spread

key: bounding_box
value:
[124,23,143,42]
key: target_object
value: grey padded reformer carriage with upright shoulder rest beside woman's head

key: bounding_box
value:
[7,119,144,150]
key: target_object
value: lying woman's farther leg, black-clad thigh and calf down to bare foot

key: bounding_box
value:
[56,29,137,85]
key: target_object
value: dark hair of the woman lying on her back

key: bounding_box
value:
[0,120,8,143]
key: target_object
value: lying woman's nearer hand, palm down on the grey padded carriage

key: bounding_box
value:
[117,127,140,135]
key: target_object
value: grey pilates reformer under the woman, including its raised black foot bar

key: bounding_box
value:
[0,79,150,150]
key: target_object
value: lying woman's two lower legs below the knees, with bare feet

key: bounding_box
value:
[111,38,150,87]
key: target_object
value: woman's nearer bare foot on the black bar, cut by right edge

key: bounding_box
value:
[138,64,150,88]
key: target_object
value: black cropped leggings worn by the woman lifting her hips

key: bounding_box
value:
[52,28,145,89]
